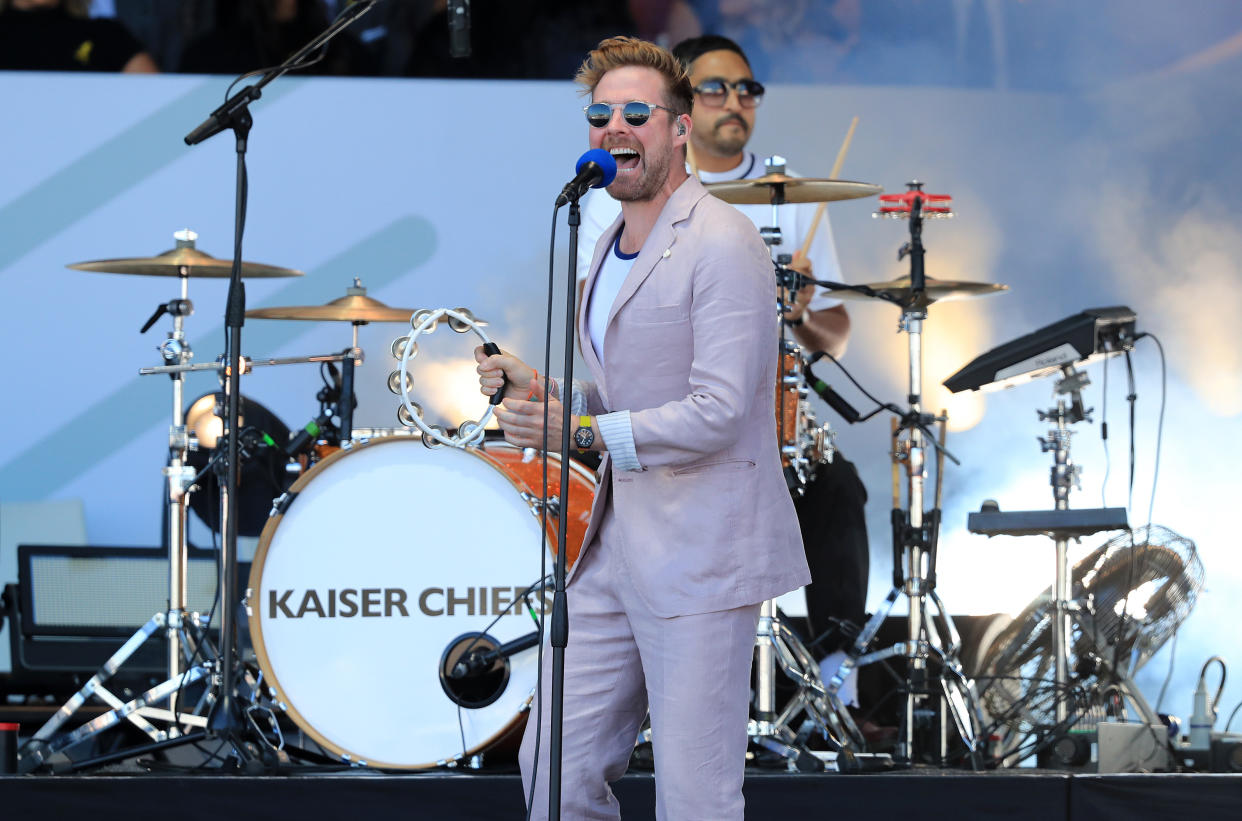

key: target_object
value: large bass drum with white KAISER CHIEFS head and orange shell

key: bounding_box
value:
[247,436,594,770]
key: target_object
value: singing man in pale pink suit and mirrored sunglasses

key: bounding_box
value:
[476,37,810,821]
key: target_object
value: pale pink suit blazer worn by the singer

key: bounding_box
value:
[568,178,811,617]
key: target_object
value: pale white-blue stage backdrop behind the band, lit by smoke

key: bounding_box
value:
[0,72,1242,714]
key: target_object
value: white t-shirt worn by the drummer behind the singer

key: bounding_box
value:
[578,152,845,311]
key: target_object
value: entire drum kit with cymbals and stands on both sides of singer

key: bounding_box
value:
[20,158,1004,771]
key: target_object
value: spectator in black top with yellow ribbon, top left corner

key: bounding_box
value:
[0,0,159,73]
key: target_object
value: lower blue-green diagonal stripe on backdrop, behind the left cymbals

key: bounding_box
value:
[0,216,437,502]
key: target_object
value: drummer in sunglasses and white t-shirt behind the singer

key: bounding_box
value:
[578,35,871,735]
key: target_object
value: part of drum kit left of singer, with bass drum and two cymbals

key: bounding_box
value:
[20,231,595,771]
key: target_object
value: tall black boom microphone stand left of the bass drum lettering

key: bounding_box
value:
[185,0,378,761]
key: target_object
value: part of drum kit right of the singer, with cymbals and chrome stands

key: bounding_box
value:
[708,162,1005,770]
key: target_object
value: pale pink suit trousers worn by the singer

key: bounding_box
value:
[520,506,759,821]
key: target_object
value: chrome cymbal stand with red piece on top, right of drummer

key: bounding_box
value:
[827,181,984,768]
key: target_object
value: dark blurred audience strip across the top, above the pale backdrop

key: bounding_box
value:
[0,0,1242,91]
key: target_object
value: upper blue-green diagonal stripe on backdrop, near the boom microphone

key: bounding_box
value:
[0,78,299,271]
